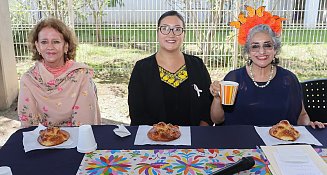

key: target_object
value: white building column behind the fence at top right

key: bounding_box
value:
[304,0,319,28]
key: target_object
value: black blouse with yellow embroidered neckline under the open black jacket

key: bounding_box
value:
[159,65,191,126]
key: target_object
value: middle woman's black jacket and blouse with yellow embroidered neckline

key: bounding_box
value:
[128,53,213,126]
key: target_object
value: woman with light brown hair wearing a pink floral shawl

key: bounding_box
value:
[18,18,100,127]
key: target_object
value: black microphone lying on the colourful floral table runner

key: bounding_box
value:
[210,156,255,175]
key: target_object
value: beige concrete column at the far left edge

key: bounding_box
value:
[0,0,18,110]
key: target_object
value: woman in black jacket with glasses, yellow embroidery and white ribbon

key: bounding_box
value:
[128,11,212,126]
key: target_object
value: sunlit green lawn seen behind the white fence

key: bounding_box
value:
[17,44,327,84]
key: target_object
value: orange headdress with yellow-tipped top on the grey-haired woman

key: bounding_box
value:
[229,5,286,45]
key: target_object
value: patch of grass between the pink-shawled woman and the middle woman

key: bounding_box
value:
[76,44,150,83]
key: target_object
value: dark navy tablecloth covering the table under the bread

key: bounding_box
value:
[0,125,327,175]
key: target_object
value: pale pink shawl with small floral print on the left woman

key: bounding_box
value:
[17,62,97,126]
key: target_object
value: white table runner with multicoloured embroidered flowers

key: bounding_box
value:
[77,149,327,175]
